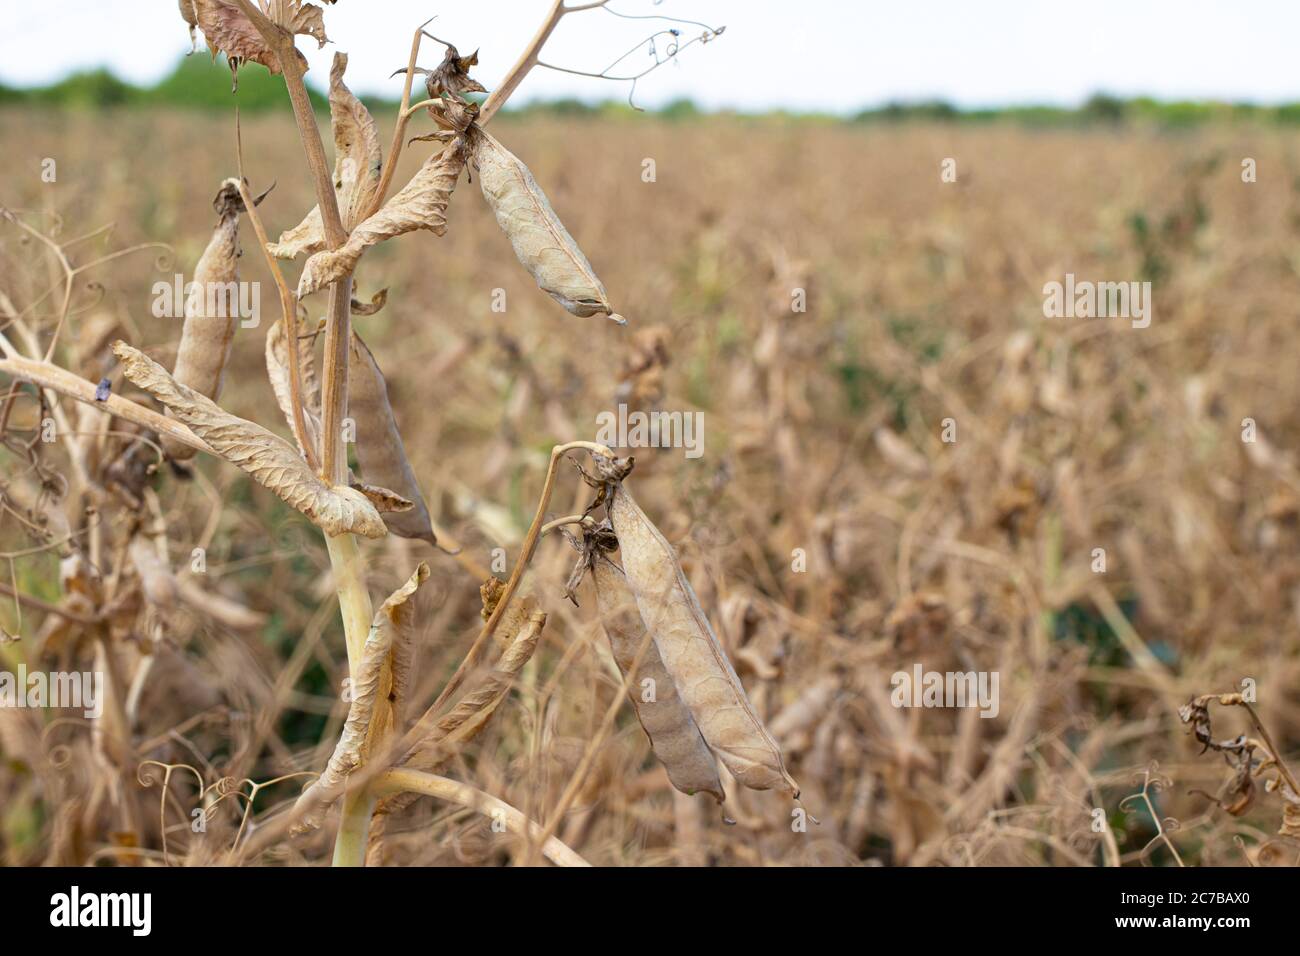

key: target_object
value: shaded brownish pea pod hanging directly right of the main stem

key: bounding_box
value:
[347,332,437,545]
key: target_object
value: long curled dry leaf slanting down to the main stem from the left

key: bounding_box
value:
[113,341,387,537]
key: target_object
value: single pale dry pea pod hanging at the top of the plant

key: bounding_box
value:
[471,126,624,324]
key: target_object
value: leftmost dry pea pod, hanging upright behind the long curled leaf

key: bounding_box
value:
[163,179,244,462]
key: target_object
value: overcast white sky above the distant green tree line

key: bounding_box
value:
[0,0,1300,112]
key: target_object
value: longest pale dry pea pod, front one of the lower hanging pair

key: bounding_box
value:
[607,483,800,796]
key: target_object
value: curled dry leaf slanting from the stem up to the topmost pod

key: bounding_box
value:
[298,142,465,299]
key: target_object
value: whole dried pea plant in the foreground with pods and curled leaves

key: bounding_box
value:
[0,0,754,865]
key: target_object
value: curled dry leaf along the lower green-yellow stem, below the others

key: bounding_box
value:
[296,562,429,831]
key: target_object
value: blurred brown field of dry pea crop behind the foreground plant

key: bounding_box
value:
[0,76,1300,866]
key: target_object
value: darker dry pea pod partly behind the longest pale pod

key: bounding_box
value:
[592,554,724,803]
